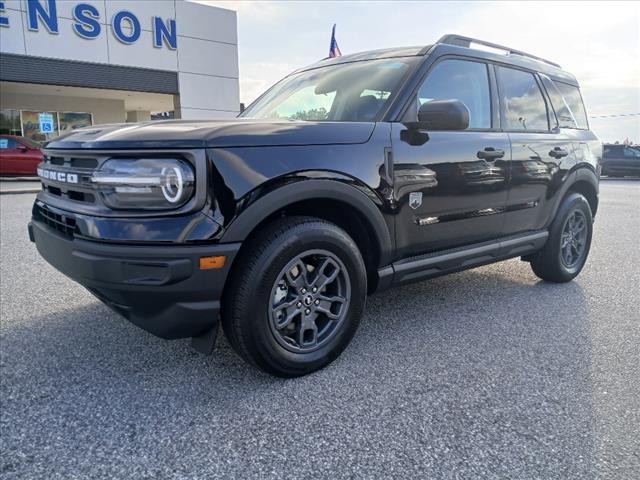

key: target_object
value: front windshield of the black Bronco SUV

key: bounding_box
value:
[241,57,417,122]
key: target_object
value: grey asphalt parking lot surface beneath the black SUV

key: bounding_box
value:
[0,180,640,480]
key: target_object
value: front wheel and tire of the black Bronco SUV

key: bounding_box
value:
[222,217,367,377]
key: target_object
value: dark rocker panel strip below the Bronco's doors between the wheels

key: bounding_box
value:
[379,230,549,289]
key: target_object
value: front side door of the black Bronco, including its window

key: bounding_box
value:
[392,58,510,258]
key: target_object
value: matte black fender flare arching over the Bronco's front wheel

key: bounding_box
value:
[220,179,393,266]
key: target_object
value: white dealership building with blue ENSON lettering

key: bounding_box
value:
[0,0,240,141]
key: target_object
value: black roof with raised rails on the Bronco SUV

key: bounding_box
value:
[294,35,578,85]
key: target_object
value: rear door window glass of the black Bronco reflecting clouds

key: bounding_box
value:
[498,67,549,130]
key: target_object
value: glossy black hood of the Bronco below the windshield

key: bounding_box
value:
[46,118,375,150]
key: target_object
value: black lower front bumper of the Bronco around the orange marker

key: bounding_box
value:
[29,219,240,339]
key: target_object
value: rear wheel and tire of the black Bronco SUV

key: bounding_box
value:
[531,193,593,283]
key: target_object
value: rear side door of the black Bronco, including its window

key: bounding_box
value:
[495,66,576,235]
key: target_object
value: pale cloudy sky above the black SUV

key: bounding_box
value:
[196,0,640,143]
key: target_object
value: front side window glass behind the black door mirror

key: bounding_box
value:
[413,60,491,128]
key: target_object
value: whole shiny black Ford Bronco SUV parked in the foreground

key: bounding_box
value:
[29,35,602,376]
